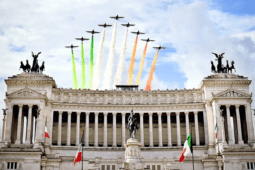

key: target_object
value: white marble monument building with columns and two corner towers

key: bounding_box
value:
[0,73,255,170]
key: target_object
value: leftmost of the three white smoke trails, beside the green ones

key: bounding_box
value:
[92,28,105,90]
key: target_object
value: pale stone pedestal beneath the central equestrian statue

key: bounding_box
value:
[124,138,143,170]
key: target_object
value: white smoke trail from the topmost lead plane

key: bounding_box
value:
[103,21,117,89]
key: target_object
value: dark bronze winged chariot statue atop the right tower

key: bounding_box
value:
[211,53,236,73]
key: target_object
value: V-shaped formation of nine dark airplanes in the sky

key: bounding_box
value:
[66,15,166,51]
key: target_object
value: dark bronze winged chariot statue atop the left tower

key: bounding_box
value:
[20,52,45,73]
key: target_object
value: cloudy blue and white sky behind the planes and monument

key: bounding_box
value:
[0,0,255,139]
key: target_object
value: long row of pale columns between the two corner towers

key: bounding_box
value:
[51,111,205,147]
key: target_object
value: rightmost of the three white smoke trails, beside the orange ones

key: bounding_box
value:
[114,28,128,85]
